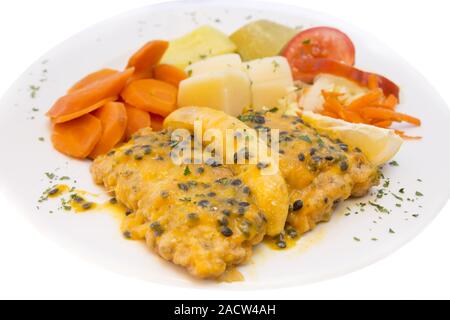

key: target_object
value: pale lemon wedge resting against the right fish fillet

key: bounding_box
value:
[300,111,403,166]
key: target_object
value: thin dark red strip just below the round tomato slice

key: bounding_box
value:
[293,59,400,99]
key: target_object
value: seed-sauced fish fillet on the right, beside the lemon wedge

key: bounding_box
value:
[240,110,379,233]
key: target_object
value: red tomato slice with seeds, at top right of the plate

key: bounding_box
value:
[282,27,355,82]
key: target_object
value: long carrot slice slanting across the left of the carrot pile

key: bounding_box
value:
[47,68,134,123]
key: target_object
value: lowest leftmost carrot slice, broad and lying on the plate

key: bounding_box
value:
[52,114,102,159]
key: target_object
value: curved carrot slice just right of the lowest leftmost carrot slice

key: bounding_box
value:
[89,102,127,159]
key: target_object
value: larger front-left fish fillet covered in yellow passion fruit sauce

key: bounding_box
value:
[91,129,288,278]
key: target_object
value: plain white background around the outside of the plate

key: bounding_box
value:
[0,0,450,299]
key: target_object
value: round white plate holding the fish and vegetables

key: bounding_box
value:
[0,1,450,289]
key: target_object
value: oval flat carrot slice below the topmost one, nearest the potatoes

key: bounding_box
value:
[122,79,178,117]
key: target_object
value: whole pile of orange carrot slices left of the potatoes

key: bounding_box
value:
[47,41,187,159]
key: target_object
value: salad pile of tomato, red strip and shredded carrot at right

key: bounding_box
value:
[283,27,421,139]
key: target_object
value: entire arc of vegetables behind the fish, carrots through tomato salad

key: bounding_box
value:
[47,20,421,159]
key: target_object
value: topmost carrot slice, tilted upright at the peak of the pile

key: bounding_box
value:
[127,40,169,74]
